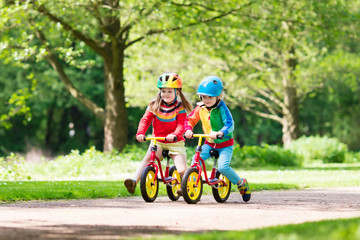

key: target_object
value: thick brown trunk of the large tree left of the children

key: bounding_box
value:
[104,52,128,152]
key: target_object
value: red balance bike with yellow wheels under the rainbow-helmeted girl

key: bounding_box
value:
[140,137,181,202]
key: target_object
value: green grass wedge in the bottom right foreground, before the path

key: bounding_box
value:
[146,218,360,240]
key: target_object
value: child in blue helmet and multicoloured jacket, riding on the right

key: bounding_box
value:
[183,76,251,202]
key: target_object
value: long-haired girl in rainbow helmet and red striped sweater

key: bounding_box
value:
[124,73,192,193]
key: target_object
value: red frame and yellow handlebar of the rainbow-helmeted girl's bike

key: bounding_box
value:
[145,137,180,184]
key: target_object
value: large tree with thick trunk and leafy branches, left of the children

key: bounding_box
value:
[0,0,253,151]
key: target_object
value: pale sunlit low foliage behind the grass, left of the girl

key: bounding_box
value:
[0,146,146,181]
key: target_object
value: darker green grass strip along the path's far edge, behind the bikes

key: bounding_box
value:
[0,181,296,202]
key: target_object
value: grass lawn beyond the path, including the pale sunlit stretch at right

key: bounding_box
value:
[0,163,360,202]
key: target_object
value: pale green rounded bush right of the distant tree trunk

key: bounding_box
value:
[289,136,348,163]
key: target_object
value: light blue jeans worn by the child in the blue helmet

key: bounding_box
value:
[192,144,241,185]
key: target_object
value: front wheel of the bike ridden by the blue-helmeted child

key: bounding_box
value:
[181,168,203,204]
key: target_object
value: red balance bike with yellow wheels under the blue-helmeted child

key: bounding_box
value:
[181,134,231,204]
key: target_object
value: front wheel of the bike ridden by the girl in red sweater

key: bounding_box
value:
[140,166,159,202]
